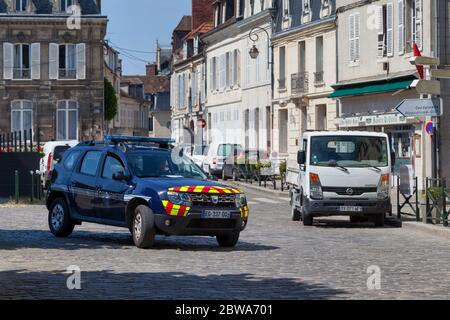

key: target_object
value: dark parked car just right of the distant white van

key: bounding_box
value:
[222,149,270,181]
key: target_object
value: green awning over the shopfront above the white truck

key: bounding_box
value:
[330,78,415,98]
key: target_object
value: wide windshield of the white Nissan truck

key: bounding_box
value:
[310,136,389,168]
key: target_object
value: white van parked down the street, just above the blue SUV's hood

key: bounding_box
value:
[203,143,243,177]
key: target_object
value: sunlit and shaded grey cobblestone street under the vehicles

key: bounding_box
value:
[0,185,450,299]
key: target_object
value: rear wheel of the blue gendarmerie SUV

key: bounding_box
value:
[48,198,75,238]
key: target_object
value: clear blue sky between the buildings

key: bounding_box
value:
[102,0,191,75]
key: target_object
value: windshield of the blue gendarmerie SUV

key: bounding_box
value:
[127,151,207,179]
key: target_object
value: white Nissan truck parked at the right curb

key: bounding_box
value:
[291,131,395,227]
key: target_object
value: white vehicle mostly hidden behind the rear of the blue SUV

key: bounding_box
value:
[39,141,78,189]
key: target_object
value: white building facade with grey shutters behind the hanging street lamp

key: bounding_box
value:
[202,0,274,151]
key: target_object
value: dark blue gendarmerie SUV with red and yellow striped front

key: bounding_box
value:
[47,135,249,248]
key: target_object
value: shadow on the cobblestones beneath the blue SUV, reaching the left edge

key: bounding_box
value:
[0,230,279,252]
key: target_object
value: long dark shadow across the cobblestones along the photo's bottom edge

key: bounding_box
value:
[0,270,346,300]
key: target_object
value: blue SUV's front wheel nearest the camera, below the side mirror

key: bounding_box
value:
[133,205,156,249]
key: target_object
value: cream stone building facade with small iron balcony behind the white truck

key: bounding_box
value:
[272,0,337,168]
